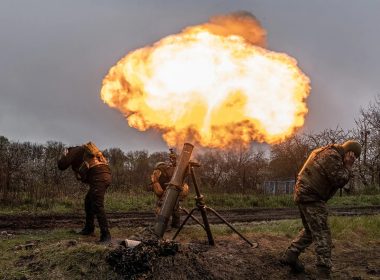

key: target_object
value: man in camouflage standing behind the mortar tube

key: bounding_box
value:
[150,149,189,228]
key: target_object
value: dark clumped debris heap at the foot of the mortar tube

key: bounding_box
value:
[107,240,179,279]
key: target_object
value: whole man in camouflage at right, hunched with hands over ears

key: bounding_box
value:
[281,140,361,279]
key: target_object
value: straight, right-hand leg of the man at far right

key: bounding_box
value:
[305,202,332,278]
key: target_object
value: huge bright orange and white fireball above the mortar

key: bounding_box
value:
[101,13,310,147]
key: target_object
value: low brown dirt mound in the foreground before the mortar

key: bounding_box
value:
[107,240,296,280]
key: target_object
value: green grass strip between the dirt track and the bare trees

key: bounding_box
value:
[0,191,380,214]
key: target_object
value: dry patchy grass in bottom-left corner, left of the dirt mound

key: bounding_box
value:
[0,230,117,279]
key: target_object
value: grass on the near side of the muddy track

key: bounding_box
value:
[0,215,380,280]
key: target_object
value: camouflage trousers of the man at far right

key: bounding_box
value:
[288,201,332,269]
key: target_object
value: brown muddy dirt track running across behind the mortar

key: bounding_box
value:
[0,206,380,230]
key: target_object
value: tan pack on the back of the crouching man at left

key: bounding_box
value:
[77,142,108,181]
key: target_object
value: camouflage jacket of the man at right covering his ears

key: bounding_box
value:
[294,145,351,203]
